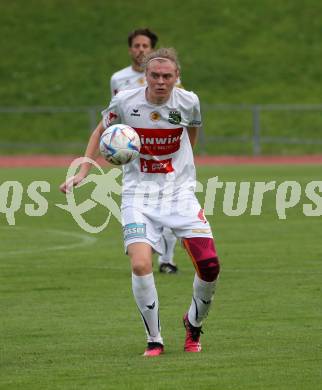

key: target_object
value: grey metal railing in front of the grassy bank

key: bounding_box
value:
[0,103,322,155]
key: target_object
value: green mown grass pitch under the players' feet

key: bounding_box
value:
[0,166,322,390]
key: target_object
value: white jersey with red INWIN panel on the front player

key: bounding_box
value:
[102,87,201,199]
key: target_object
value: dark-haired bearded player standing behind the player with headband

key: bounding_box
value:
[110,28,181,274]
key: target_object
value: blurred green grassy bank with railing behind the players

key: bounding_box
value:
[0,0,322,155]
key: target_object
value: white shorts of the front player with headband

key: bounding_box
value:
[121,195,213,254]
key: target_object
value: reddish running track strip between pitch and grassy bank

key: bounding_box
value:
[0,155,322,168]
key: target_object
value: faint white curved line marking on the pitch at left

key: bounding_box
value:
[0,226,97,258]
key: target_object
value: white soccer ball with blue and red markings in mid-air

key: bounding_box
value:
[99,124,141,165]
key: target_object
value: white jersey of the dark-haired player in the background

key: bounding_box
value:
[110,66,181,96]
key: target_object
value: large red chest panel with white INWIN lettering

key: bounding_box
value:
[134,127,183,156]
